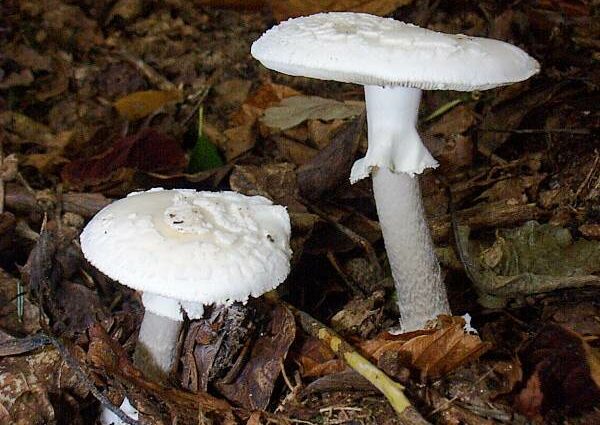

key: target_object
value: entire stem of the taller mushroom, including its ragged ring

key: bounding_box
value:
[350,86,450,331]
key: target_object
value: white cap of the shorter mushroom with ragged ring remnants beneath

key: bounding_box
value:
[81,189,291,318]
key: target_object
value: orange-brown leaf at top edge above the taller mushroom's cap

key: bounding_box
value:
[269,0,413,21]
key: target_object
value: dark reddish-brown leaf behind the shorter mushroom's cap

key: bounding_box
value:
[61,128,186,187]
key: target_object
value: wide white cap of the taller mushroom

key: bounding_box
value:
[252,12,539,91]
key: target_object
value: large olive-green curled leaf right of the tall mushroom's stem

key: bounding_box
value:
[456,221,600,307]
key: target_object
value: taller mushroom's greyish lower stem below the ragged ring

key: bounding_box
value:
[373,167,450,332]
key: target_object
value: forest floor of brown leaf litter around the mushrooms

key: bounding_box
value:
[0,0,600,425]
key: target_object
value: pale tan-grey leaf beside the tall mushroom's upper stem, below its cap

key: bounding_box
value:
[261,96,364,130]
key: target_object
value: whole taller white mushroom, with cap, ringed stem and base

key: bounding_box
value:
[252,12,539,331]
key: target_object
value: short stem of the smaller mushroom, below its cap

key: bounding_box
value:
[133,310,183,382]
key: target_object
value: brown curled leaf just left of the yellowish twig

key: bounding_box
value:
[216,305,296,410]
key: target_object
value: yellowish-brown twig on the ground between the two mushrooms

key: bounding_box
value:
[265,291,429,425]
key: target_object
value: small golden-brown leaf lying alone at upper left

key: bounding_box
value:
[114,90,181,121]
